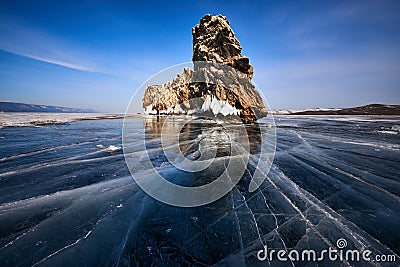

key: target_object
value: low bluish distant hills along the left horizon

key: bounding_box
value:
[0,102,97,113]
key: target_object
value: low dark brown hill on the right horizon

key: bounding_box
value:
[290,104,400,115]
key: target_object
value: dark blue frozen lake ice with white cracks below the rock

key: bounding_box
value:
[0,116,400,266]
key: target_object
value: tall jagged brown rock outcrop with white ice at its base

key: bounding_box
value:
[143,15,267,122]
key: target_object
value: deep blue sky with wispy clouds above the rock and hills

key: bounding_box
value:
[0,0,400,113]
